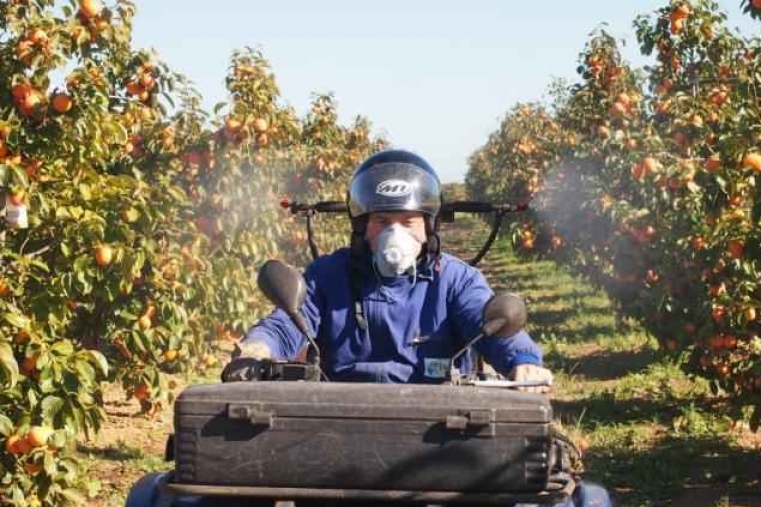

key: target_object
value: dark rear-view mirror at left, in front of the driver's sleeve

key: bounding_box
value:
[256,259,309,335]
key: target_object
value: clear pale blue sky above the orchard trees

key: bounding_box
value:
[134,0,761,181]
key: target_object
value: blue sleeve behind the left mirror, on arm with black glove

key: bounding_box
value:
[242,263,323,360]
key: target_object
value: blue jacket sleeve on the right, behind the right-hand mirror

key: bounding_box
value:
[452,269,542,375]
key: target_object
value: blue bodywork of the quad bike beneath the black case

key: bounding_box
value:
[125,472,612,507]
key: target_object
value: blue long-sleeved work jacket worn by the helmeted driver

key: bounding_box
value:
[244,248,542,383]
